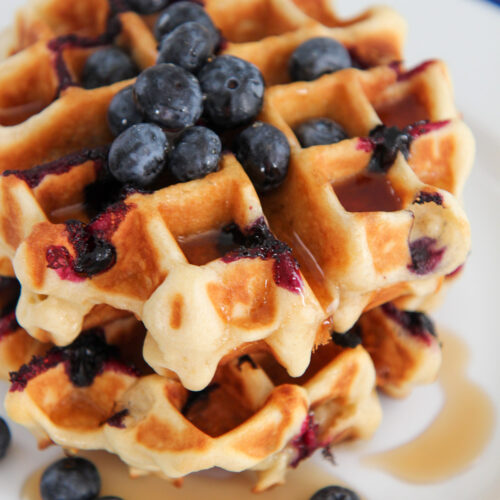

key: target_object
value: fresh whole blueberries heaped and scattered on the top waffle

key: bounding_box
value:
[82,0,352,193]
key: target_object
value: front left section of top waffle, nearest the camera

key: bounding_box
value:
[7,155,324,390]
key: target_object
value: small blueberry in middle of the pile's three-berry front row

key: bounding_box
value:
[168,127,222,182]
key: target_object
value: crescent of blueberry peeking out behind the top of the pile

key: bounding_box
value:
[155,2,220,46]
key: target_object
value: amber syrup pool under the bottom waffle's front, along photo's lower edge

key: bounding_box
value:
[20,452,364,500]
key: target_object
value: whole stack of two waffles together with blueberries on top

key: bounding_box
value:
[0,0,474,492]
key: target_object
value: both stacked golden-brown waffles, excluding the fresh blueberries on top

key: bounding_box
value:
[0,0,473,491]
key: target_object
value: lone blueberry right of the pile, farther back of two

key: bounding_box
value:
[288,38,351,81]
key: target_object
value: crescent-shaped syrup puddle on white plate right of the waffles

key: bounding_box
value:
[363,333,495,483]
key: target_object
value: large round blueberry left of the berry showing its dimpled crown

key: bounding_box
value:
[134,63,203,130]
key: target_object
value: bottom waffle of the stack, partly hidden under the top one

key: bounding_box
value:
[0,303,441,492]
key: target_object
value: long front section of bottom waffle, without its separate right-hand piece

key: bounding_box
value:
[6,324,381,491]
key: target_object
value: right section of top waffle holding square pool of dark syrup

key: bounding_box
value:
[261,63,473,331]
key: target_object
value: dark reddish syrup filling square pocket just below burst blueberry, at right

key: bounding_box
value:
[332,172,402,212]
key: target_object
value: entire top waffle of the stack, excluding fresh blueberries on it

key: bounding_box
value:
[0,0,473,390]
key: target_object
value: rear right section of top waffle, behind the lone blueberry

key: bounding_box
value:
[206,0,406,85]
